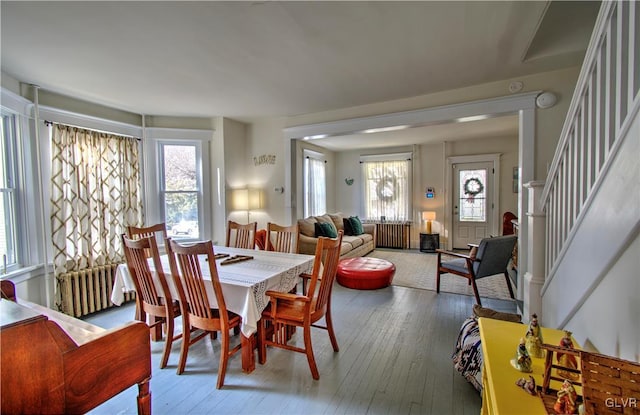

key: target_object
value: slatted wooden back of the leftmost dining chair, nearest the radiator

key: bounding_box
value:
[122,235,172,306]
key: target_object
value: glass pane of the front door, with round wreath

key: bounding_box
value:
[458,169,487,222]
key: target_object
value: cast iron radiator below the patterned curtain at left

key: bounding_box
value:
[56,264,135,317]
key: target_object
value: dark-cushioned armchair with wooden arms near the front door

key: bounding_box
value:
[436,235,517,305]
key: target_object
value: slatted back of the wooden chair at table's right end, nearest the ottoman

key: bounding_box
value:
[307,231,343,311]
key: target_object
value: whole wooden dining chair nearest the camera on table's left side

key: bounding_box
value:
[166,240,242,389]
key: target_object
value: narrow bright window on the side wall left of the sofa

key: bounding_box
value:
[304,150,327,217]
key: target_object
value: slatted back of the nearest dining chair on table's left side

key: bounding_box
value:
[167,240,228,326]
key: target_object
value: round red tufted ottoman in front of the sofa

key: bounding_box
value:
[336,257,396,290]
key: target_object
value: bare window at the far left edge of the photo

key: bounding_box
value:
[0,114,18,271]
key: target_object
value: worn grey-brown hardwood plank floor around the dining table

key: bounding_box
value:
[86,284,515,415]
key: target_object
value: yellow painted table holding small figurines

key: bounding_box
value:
[478,318,581,415]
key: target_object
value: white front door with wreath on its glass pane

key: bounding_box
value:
[452,162,494,249]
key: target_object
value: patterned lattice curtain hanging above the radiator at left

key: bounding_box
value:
[51,124,143,275]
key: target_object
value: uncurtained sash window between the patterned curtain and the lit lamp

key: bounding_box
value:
[160,142,202,239]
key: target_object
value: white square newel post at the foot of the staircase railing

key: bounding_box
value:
[522,181,546,320]
